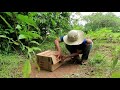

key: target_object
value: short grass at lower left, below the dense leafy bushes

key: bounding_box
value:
[0,54,24,78]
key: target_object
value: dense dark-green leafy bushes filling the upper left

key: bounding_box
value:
[0,12,70,57]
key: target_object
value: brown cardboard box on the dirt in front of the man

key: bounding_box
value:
[37,50,63,71]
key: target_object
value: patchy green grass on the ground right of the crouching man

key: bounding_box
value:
[89,42,120,78]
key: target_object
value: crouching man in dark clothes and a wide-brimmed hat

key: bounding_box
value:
[54,30,93,64]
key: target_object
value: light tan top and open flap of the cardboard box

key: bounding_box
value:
[37,50,61,64]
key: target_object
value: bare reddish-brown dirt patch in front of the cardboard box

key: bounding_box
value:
[31,61,80,78]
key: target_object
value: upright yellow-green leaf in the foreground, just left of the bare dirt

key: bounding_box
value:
[22,60,31,78]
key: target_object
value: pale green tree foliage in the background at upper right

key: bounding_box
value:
[82,12,120,32]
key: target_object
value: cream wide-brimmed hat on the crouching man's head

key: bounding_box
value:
[63,30,84,45]
